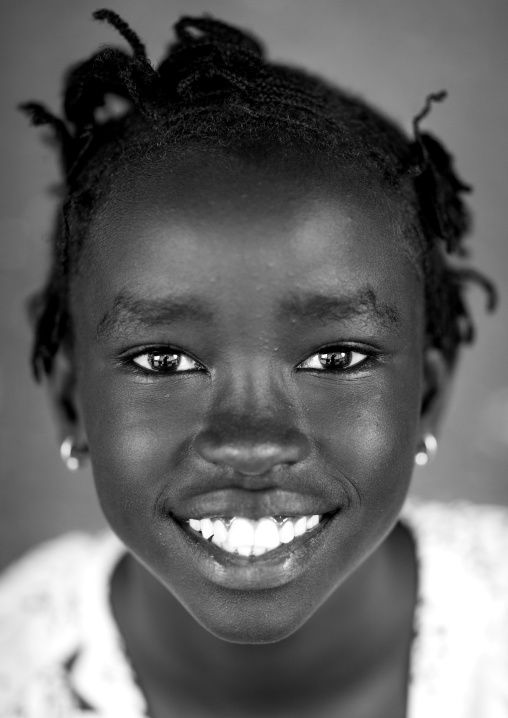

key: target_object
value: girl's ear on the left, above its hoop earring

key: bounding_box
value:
[45,347,87,451]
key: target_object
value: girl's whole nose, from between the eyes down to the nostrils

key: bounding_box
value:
[194,367,310,475]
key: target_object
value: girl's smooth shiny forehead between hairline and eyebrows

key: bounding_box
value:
[74,154,419,334]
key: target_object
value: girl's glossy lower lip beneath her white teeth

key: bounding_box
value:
[168,511,340,591]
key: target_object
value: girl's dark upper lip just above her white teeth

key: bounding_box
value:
[171,488,340,520]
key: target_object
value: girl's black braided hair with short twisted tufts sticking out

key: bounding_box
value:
[21,10,496,378]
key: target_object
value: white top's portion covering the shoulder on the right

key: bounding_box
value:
[401,499,508,718]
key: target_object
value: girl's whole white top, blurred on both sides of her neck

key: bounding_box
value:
[0,500,508,718]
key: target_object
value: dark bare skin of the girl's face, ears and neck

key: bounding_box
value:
[46,156,448,718]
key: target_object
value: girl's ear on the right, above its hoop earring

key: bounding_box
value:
[420,347,453,436]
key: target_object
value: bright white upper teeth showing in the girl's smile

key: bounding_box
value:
[189,514,321,556]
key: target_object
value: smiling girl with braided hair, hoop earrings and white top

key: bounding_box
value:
[0,10,508,718]
